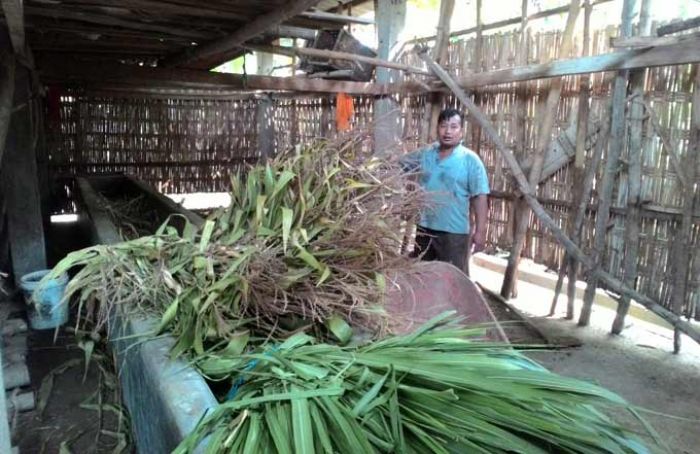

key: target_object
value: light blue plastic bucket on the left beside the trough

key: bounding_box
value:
[19,270,68,330]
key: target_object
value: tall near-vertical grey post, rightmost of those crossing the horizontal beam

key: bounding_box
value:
[611,0,656,334]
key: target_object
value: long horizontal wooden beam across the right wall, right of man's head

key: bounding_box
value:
[459,42,700,89]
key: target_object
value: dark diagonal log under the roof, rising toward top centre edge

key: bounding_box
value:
[163,0,319,68]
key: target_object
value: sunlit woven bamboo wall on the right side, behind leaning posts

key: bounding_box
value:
[403,29,700,320]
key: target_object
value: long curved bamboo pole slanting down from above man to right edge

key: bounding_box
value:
[419,47,700,343]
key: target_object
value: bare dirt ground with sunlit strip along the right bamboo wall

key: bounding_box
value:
[472,260,700,454]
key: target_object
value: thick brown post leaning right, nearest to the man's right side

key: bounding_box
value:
[501,0,580,298]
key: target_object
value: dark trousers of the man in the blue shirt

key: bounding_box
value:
[411,226,471,276]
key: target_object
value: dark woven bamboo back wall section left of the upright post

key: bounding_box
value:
[49,92,259,193]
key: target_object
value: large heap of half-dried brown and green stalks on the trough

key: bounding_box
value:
[47,137,422,354]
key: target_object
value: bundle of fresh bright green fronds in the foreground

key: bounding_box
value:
[175,314,648,454]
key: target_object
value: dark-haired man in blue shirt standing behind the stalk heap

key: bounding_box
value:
[401,109,489,275]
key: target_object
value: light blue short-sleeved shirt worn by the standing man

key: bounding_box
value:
[401,143,489,234]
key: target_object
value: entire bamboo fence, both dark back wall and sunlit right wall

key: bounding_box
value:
[49,28,700,320]
